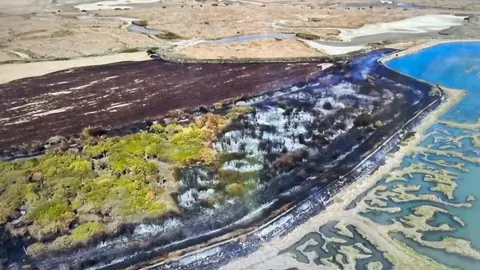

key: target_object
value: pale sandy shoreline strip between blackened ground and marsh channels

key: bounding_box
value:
[220,82,466,270]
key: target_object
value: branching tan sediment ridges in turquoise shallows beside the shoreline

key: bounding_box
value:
[279,118,480,269]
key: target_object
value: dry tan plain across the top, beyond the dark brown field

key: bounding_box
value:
[0,1,476,62]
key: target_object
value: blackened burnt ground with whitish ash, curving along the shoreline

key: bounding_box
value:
[0,50,442,269]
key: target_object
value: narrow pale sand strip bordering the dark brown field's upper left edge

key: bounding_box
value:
[0,52,150,83]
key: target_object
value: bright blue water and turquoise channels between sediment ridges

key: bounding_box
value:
[382,42,480,269]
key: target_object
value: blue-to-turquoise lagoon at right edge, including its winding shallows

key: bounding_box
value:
[374,42,480,269]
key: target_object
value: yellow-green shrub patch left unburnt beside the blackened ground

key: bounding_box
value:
[0,114,236,256]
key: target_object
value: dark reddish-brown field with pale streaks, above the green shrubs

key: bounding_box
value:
[0,59,321,149]
